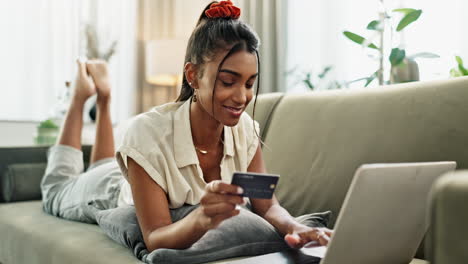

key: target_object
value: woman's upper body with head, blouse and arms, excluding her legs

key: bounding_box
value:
[117,1,330,251]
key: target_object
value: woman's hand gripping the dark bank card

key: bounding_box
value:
[198,180,244,230]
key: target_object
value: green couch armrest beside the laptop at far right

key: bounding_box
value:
[426,170,468,264]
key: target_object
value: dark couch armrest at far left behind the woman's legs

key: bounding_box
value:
[0,146,91,202]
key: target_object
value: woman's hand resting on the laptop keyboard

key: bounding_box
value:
[284,224,333,248]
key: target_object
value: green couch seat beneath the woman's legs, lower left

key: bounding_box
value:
[0,201,142,264]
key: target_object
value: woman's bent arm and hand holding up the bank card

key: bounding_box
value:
[127,158,243,252]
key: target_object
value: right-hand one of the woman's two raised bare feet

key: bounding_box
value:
[86,60,111,101]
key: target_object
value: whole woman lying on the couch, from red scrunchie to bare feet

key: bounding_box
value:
[41,1,330,251]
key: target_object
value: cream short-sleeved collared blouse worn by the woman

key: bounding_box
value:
[116,100,260,208]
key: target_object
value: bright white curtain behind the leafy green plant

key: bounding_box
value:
[287,0,468,92]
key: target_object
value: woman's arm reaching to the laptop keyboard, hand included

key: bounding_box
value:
[247,145,331,248]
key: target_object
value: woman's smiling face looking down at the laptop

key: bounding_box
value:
[197,51,258,126]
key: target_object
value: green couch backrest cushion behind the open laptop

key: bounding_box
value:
[263,78,468,227]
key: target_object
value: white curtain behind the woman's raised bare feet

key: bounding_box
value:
[0,0,136,121]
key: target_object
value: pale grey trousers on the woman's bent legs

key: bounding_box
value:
[41,145,124,223]
